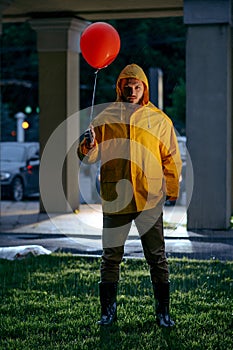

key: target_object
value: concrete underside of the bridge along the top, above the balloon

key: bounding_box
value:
[2,0,183,21]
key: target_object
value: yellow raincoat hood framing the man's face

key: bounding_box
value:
[116,63,149,105]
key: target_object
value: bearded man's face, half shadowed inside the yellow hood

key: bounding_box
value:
[120,78,144,104]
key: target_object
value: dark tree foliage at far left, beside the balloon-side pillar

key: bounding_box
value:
[1,22,38,114]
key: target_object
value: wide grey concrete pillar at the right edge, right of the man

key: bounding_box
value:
[184,0,232,230]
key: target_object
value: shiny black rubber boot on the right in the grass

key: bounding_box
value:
[152,282,175,327]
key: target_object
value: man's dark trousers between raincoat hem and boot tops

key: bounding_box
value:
[100,210,169,283]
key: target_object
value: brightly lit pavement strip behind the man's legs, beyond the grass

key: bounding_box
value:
[0,200,233,260]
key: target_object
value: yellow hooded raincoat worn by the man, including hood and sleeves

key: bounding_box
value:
[78,64,182,214]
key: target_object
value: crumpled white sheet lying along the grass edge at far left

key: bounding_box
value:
[0,245,52,260]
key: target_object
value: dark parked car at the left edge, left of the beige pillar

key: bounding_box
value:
[0,142,40,201]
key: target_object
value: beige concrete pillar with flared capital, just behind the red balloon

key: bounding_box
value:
[31,18,88,213]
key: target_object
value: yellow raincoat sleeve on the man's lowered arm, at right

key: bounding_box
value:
[160,121,182,199]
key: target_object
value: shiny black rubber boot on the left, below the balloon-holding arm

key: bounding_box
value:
[97,282,118,326]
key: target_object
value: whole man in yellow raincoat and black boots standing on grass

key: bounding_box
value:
[78,64,182,327]
